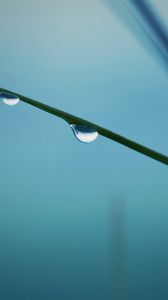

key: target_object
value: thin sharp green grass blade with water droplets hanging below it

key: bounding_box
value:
[0,88,168,165]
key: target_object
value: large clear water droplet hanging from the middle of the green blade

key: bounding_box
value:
[70,124,98,143]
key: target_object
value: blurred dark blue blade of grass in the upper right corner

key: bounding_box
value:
[102,0,168,71]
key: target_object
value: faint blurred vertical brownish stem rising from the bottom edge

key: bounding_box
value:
[110,197,126,300]
